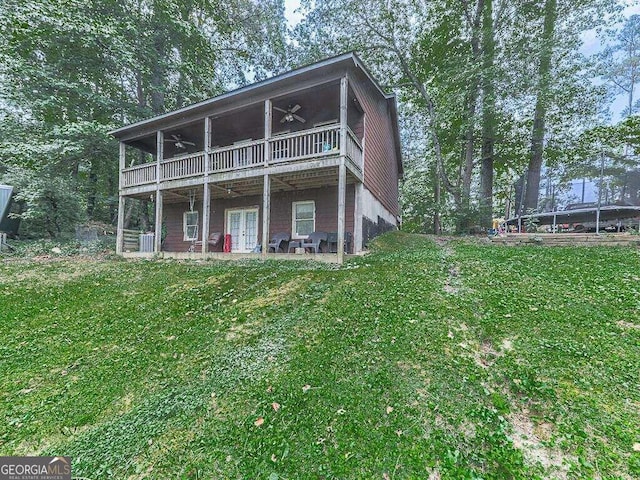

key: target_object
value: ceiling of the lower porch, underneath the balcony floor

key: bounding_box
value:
[133,167,357,204]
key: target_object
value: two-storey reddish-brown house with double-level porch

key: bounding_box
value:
[111,53,402,263]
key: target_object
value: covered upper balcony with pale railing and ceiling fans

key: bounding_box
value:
[120,81,364,194]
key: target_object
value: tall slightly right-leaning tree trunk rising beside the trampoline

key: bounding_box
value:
[524,0,557,213]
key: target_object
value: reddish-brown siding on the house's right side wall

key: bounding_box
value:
[349,73,400,216]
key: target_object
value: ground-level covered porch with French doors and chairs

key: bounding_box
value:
[117,160,362,262]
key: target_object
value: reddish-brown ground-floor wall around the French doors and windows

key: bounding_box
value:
[162,185,355,252]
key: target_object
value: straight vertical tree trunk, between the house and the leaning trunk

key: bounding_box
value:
[480,0,495,228]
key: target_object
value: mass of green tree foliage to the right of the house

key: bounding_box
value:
[294,0,618,231]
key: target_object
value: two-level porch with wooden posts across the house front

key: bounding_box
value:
[117,77,364,263]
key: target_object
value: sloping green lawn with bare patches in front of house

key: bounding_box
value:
[0,233,640,480]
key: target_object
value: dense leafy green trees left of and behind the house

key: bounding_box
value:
[0,0,287,234]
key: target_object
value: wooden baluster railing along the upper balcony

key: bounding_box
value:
[122,124,362,188]
